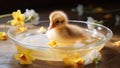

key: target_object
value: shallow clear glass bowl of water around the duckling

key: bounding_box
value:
[7,20,112,68]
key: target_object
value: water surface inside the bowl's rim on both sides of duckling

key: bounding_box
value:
[16,30,105,47]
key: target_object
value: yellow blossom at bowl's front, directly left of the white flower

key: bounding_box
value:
[63,53,84,65]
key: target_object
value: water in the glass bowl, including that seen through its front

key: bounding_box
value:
[16,30,104,61]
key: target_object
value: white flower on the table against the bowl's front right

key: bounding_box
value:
[83,50,101,65]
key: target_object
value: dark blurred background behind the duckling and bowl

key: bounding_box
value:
[0,0,120,32]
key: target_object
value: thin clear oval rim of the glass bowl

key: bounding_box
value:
[7,20,113,49]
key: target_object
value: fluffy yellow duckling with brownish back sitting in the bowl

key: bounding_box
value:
[47,11,87,45]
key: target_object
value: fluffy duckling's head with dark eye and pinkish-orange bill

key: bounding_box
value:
[48,11,68,29]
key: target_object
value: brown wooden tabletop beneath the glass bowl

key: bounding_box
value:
[0,11,120,68]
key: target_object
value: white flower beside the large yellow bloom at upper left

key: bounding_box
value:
[24,9,40,25]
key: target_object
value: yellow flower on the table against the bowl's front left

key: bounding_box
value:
[15,45,35,64]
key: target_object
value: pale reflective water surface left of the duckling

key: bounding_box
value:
[16,33,49,47]
